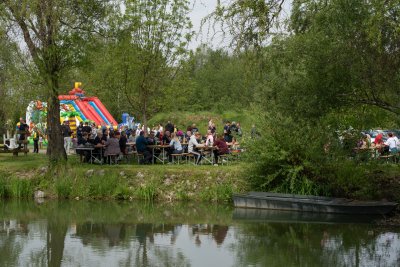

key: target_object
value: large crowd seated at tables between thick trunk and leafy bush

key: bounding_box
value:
[61,119,242,165]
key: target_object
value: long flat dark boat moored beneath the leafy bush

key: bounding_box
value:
[233,192,397,215]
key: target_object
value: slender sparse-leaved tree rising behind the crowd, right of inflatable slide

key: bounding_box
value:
[121,0,193,132]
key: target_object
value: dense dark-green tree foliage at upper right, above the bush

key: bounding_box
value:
[288,0,400,114]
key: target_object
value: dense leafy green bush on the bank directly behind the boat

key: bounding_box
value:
[247,108,400,200]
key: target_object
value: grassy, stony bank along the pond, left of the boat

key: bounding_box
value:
[0,154,248,201]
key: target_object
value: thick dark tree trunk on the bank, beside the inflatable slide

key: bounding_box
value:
[47,76,67,164]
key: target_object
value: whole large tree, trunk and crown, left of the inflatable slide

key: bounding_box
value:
[0,0,109,163]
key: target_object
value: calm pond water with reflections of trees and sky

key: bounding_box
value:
[0,201,400,267]
